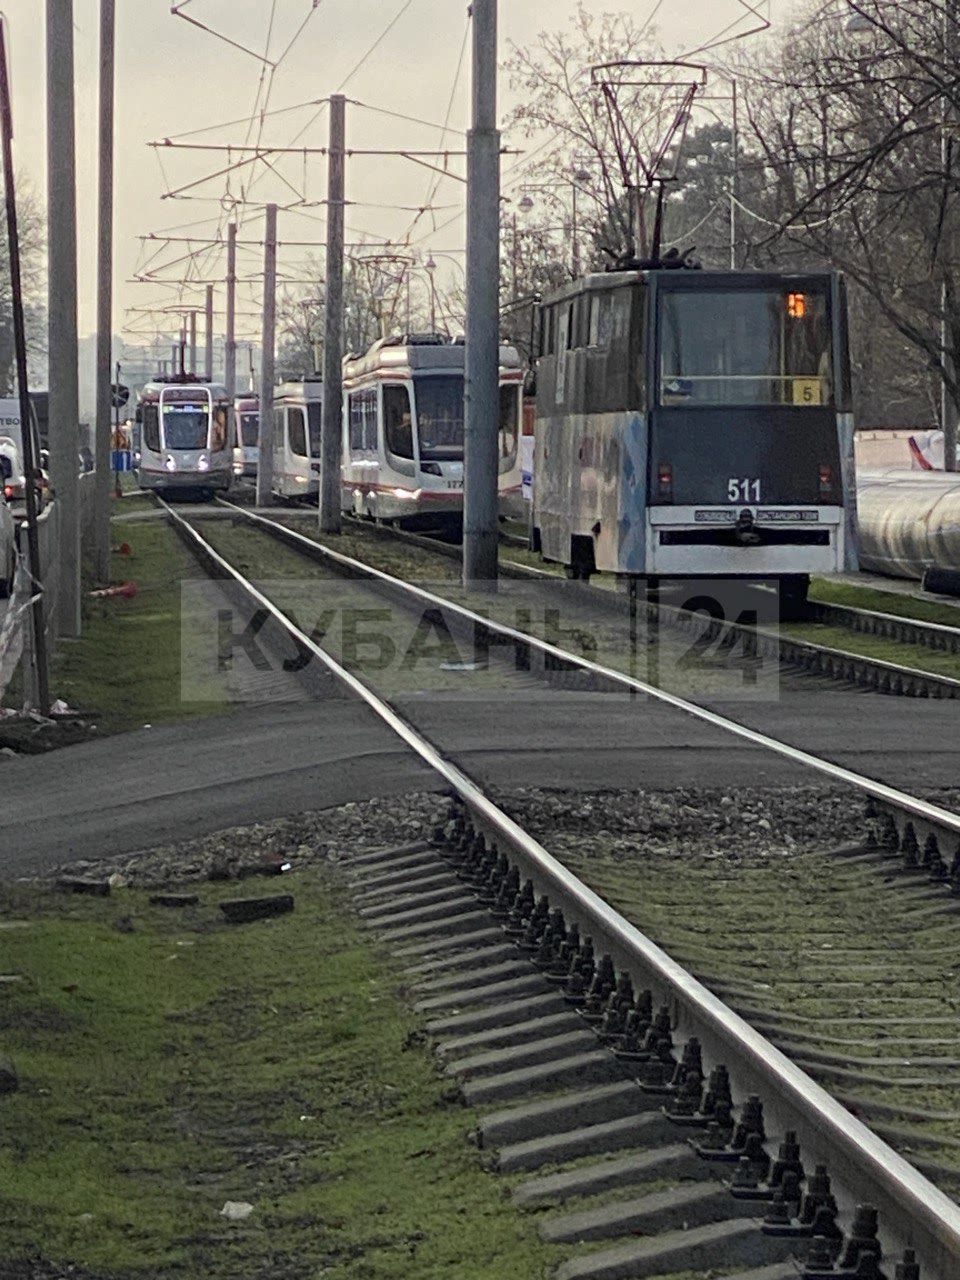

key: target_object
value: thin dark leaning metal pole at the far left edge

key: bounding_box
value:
[0,17,50,714]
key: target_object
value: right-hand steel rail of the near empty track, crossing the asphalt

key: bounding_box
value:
[220,499,960,860]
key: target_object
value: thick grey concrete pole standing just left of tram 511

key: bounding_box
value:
[463,0,500,591]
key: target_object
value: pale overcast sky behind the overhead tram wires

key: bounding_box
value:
[4,0,786,355]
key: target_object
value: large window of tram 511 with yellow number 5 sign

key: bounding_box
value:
[659,288,833,406]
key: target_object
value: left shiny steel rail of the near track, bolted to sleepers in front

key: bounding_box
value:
[161,499,960,1280]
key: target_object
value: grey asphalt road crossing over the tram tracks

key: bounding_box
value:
[0,690,960,876]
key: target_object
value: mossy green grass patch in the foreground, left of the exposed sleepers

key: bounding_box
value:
[0,869,564,1280]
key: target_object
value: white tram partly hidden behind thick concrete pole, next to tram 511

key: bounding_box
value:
[342,334,524,530]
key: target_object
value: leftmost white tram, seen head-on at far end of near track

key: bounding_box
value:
[136,374,233,495]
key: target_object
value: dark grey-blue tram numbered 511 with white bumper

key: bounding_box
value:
[532,266,856,613]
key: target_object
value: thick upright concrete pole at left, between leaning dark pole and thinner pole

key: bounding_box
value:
[46,0,81,636]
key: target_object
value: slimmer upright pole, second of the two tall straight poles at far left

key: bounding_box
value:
[93,0,116,582]
